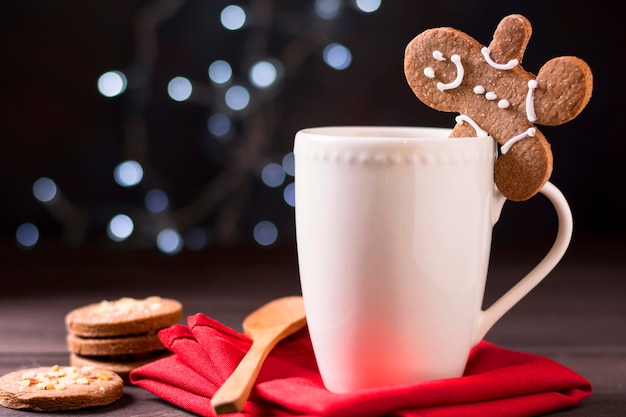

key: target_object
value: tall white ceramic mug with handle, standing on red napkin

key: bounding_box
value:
[294,127,572,392]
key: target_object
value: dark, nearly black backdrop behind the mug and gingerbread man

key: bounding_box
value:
[0,0,626,253]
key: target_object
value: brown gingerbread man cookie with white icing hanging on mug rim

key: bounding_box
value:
[404,15,592,201]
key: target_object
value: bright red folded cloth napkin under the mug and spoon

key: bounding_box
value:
[130,314,591,417]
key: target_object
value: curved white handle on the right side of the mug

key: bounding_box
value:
[473,182,573,345]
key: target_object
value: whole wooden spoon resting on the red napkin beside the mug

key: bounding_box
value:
[211,296,306,414]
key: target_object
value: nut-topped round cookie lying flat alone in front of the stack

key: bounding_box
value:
[0,365,124,411]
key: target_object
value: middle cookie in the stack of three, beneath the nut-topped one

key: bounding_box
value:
[66,332,165,356]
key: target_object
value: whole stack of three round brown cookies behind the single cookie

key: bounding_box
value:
[65,297,182,380]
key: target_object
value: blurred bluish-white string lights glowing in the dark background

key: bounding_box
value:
[16,0,381,250]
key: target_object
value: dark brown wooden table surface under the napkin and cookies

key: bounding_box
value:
[0,238,626,417]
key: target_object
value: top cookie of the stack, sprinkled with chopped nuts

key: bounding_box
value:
[65,297,183,337]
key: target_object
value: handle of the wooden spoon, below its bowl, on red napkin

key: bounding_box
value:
[211,338,278,414]
